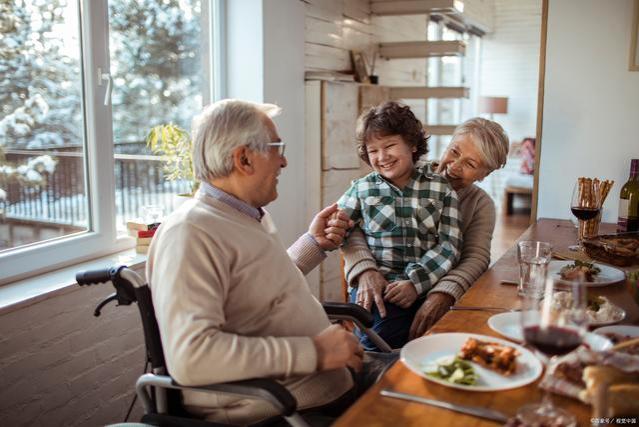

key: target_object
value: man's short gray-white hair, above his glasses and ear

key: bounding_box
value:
[192,99,282,181]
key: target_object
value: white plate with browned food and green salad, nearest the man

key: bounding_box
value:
[400,333,543,391]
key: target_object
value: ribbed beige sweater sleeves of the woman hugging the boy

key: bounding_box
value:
[342,185,495,301]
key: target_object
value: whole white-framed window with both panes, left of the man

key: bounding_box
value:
[0,0,221,283]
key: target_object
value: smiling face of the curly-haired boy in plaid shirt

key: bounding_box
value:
[366,135,416,188]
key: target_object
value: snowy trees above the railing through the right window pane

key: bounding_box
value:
[109,0,202,143]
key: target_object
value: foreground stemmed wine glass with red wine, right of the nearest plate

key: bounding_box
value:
[517,278,588,426]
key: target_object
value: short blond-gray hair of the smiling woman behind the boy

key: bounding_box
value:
[453,117,510,173]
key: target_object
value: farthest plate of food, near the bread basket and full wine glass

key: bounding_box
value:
[548,261,626,286]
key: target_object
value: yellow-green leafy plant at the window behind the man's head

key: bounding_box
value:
[146,123,200,197]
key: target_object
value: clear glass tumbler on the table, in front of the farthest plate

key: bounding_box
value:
[517,240,552,298]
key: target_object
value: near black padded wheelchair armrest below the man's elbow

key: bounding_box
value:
[135,374,297,417]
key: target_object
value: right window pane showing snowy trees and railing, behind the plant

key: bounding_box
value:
[109,0,206,233]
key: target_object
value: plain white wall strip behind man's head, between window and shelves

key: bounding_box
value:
[226,0,308,246]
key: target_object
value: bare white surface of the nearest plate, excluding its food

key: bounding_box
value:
[400,333,543,391]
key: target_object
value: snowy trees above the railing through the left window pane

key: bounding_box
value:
[0,0,83,148]
